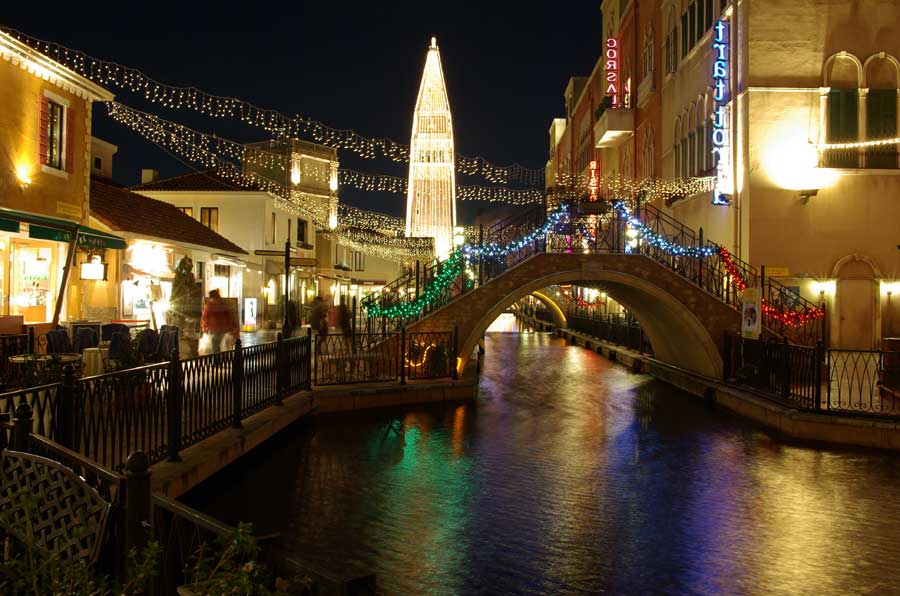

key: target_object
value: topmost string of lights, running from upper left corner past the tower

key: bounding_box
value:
[0,27,544,186]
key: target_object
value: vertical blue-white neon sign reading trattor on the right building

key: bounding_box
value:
[712,20,734,205]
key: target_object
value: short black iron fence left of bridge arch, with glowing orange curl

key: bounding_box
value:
[313,329,456,385]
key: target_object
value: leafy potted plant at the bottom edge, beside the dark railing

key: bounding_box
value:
[178,523,313,596]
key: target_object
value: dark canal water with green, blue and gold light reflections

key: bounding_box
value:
[186,314,900,595]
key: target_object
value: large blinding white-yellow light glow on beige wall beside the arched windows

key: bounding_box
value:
[762,126,839,190]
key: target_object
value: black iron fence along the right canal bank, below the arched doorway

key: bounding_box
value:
[725,336,900,418]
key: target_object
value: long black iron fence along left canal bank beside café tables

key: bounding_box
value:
[0,336,312,470]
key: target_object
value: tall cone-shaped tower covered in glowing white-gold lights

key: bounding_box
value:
[406,37,456,257]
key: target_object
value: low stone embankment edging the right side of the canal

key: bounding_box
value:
[520,315,900,450]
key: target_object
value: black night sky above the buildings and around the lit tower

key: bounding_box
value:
[3,0,602,222]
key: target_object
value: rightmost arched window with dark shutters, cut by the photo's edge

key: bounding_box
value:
[863,52,900,169]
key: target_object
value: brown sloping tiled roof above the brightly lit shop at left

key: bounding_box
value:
[91,178,247,254]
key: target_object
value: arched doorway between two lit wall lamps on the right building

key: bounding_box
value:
[832,255,880,350]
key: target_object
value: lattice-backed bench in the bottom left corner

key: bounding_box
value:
[0,449,111,567]
